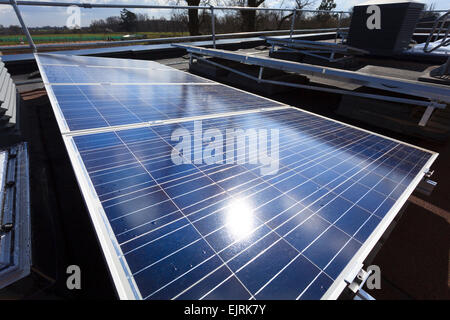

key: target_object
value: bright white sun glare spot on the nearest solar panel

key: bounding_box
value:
[226,199,255,238]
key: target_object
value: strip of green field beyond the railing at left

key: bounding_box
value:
[0,32,189,45]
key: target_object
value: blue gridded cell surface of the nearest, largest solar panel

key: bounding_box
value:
[73,108,431,299]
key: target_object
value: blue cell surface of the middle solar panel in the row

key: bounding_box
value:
[52,84,281,131]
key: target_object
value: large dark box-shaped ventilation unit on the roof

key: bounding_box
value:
[348,0,425,55]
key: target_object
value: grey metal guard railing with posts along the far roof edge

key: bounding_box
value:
[0,0,351,52]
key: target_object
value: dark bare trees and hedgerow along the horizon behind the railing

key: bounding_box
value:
[0,0,442,36]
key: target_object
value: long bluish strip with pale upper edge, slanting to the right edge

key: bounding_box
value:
[176,44,450,107]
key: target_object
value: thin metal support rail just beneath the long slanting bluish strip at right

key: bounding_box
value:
[194,55,445,108]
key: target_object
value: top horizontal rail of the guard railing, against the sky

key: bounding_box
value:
[0,0,351,13]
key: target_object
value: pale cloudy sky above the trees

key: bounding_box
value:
[0,0,449,27]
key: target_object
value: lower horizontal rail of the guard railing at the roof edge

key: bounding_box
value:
[0,28,344,51]
